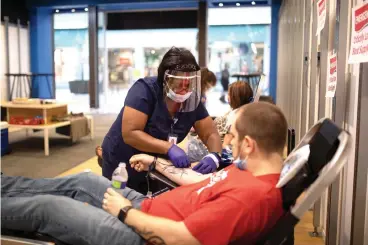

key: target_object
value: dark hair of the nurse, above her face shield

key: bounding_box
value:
[157,47,200,85]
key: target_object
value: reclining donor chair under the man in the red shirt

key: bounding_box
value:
[1,119,351,245]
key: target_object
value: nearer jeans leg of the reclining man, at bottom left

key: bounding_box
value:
[1,195,144,245]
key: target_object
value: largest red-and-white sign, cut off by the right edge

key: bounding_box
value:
[349,2,368,64]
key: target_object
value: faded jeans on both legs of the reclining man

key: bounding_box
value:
[1,173,146,245]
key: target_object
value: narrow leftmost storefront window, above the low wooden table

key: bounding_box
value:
[54,12,89,111]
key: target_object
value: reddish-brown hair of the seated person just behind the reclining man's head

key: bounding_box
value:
[229,81,253,109]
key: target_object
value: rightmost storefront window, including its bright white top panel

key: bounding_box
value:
[208,7,271,95]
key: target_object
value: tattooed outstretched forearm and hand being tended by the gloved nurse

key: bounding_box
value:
[130,154,211,185]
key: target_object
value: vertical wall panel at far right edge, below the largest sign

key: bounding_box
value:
[350,63,368,245]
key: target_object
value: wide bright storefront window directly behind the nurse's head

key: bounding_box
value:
[106,29,197,83]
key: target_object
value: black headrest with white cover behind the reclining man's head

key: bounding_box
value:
[277,119,349,210]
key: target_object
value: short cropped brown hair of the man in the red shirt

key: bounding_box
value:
[235,102,288,154]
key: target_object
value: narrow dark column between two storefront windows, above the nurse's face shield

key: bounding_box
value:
[197,1,208,67]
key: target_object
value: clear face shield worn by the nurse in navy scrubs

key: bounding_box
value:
[164,70,201,112]
